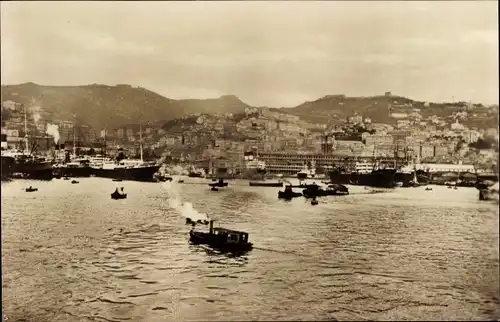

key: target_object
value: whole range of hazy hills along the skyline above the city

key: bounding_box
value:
[1,83,498,129]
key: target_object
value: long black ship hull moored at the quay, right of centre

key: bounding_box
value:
[329,169,396,188]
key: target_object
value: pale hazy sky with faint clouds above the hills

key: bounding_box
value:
[1,1,499,107]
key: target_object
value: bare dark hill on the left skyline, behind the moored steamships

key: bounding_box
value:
[1,83,248,129]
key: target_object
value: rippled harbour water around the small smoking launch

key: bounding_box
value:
[1,178,500,322]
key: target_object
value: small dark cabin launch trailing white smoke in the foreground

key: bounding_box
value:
[189,220,253,252]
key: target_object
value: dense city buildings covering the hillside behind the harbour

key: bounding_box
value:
[2,93,498,173]
